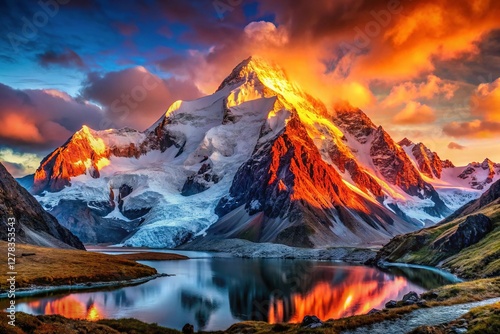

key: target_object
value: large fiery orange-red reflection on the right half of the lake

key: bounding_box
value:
[268,273,408,323]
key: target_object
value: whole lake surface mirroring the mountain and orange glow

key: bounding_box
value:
[7,258,456,330]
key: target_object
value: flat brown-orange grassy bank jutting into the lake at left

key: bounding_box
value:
[0,241,157,290]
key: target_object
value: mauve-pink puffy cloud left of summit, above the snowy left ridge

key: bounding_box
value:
[81,66,201,130]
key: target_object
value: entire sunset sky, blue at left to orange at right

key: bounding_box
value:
[0,0,500,177]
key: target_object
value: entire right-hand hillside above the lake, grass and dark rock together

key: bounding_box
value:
[377,181,500,277]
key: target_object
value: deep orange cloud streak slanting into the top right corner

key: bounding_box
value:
[353,0,500,81]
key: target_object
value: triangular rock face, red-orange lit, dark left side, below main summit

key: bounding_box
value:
[211,116,412,247]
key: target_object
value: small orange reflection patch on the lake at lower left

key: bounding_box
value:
[28,296,104,321]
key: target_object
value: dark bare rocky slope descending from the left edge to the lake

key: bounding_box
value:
[0,160,85,249]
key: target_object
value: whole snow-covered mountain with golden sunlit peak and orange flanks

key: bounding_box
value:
[32,58,498,247]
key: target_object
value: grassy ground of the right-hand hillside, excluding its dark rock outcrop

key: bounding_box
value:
[379,202,500,278]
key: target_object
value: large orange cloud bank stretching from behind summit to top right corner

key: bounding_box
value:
[160,0,500,115]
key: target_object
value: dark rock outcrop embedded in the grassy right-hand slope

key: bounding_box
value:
[433,214,493,254]
